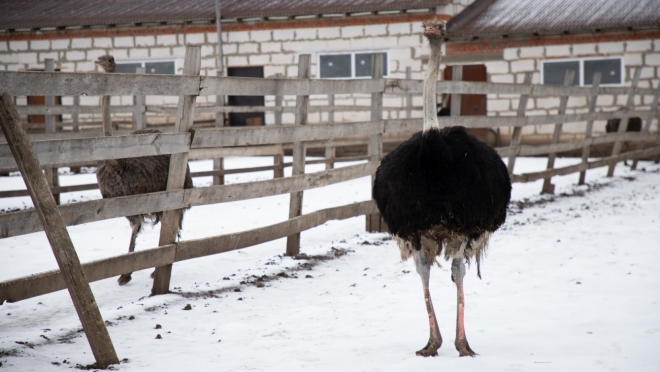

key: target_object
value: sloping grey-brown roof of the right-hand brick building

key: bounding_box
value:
[447,0,660,39]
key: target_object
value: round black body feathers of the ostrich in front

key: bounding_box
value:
[373,127,511,254]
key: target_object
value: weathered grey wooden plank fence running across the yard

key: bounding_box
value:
[0,48,660,303]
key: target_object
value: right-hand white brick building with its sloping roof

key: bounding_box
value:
[443,0,660,137]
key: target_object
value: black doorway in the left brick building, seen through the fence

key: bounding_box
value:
[227,66,266,127]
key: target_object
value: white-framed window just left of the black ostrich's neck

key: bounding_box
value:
[318,52,389,79]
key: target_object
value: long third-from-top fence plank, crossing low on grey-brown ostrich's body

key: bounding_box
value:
[0,163,377,238]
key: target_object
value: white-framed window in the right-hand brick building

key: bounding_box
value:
[541,57,623,85]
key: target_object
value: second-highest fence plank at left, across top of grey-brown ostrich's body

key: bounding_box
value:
[0,133,191,169]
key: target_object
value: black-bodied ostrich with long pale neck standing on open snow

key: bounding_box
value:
[373,20,511,357]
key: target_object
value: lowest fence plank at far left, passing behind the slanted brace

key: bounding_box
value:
[0,244,176,304]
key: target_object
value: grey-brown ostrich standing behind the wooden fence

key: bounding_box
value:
[95,55,193,285]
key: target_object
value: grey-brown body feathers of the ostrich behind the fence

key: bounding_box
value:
[96,129,193,229]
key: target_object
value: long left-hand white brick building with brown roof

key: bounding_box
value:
[0,0,472,124]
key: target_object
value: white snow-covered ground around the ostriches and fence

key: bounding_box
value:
[0,158,660,372]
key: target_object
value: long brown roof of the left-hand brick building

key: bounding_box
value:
[0,0,449,29]
